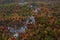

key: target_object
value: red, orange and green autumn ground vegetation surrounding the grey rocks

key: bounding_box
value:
[0,3,60,40]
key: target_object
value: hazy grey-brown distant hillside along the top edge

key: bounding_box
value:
[0,0,60,4]
